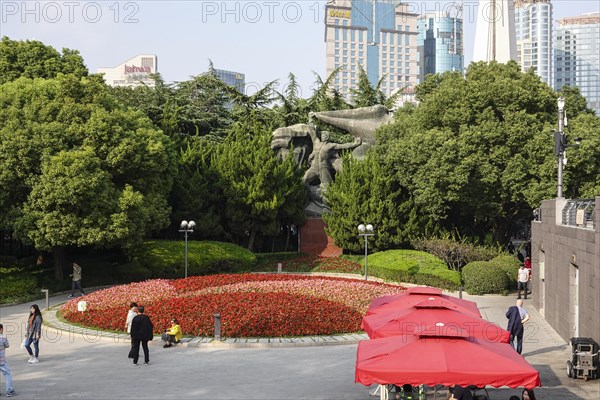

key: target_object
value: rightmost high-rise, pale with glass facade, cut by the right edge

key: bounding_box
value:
[554,13,600,115]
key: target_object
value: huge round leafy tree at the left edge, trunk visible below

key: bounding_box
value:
[0,75,174,279]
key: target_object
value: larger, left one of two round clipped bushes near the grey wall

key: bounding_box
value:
[462,261,510,295]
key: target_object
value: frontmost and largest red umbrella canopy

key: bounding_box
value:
[355,330,541,388]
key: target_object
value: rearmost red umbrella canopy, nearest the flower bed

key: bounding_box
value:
[366,288,481,317]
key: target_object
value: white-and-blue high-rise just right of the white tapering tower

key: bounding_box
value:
[515,0,554,86]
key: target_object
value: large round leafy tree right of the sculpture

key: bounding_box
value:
[379,62,600,241]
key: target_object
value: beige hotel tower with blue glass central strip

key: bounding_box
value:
[325,0,418,101]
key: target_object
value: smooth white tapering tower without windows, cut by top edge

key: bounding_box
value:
[473,0,517,63]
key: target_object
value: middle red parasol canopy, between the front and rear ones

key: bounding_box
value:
[362,298,510,343]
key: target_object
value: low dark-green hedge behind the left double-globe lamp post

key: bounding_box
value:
[134,240,256,278]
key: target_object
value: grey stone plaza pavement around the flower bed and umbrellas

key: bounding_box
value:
[0,293,600,400]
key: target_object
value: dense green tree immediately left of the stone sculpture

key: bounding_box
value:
[213,122,305,250]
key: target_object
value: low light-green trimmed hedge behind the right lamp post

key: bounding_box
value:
[363,250,460,290]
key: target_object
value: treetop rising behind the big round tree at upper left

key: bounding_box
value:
[0,36,88,84]
